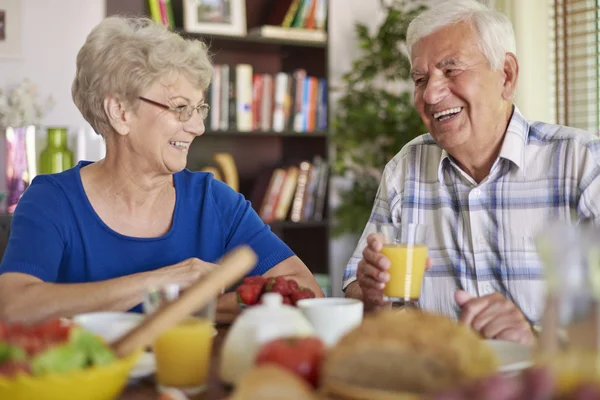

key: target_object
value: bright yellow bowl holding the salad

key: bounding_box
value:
[0,350,142,400]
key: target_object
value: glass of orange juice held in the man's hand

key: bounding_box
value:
[376,223,427,307]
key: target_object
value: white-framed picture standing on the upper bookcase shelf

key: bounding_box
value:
[183,0,246,36]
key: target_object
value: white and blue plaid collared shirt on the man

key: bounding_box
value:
[343,107,600,322]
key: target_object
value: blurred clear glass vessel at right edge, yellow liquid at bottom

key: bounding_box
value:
[536,223,600,391]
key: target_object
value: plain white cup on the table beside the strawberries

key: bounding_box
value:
[296,297,363,347]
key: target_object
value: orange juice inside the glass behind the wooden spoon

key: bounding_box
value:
[154,318,214,390]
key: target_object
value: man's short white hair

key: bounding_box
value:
[406,0,517,70]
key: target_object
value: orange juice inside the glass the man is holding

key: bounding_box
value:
[381,244,427,301]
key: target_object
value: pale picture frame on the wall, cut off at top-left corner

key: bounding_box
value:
[0,0,22,58]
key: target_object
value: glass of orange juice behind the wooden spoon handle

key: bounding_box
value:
[144,285,216,395]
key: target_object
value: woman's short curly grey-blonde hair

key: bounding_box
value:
[71,16,213,137]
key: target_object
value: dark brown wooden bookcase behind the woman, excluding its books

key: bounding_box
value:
[106,0,330,274]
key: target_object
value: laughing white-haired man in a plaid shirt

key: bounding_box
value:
[344,0,600,343]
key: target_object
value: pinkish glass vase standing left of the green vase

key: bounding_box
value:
[5,125,35,214]
